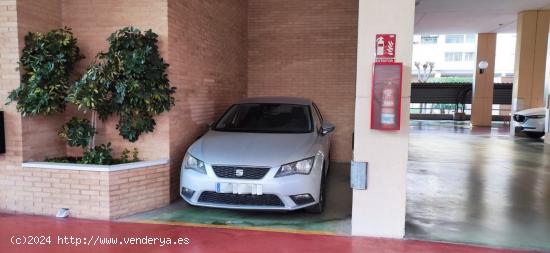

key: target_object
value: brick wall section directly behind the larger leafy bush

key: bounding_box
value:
[61,0,169,160]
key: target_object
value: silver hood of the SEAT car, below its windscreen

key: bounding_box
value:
[189,130,317,167]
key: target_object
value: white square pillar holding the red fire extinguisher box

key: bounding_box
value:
[352,0,415,238]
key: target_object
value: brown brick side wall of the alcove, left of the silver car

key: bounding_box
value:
[168,0,247,201]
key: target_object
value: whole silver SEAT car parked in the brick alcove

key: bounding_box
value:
[180,97,334,213]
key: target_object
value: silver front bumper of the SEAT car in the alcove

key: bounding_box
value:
[180,166,322,211]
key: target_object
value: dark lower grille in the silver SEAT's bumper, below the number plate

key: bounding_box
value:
[199,191,285,206]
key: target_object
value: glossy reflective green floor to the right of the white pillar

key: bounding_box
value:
[406,121,550,251]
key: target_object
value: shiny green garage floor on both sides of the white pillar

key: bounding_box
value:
[123,121,550,251]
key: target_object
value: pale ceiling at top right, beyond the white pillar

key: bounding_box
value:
[414,0,550,34]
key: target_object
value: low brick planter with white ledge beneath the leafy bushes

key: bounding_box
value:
[0,160,170,219]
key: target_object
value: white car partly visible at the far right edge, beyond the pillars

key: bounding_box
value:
[513,107,546,138]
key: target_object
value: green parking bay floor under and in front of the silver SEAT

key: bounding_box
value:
[122,163,352,235]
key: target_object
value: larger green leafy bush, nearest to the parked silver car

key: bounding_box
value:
[68,27,175,142]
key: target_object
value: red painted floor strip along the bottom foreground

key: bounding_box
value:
[0,214,544,253]
